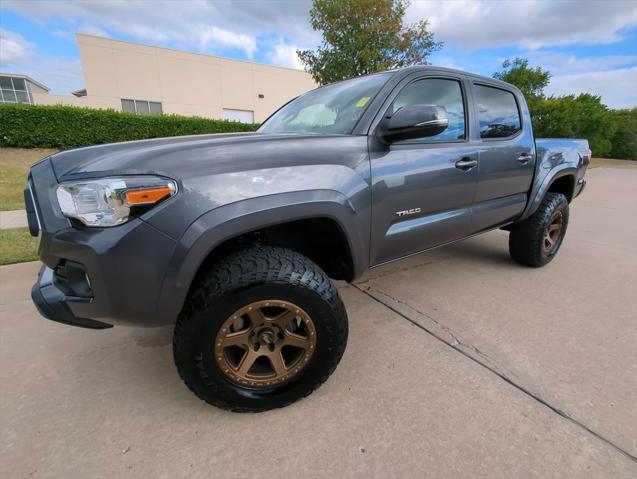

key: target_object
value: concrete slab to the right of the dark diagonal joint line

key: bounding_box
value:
[359,165,637,456]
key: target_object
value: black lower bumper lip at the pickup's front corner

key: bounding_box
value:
[31,266,113,329]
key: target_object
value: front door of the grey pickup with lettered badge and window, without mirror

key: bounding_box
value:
[370,76,479,265]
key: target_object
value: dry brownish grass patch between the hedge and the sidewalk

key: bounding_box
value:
[0,148,57,211]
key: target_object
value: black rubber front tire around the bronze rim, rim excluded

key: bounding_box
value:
[173,246,348,412]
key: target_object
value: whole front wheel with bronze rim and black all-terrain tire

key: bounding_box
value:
[173,247,348,412]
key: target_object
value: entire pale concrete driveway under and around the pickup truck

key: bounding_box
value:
[0,164,637,478]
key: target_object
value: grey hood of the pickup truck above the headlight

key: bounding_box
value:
[50,133,352,181]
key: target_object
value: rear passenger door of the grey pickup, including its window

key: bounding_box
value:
[471,83,535,233]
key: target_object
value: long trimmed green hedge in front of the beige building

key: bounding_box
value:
[0,104,258,149]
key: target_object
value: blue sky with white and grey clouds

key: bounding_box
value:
[0,0,637,108]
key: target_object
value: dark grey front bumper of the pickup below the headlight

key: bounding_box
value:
[27,160,181,329]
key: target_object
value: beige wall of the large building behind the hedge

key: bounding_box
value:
[67,34,316,122]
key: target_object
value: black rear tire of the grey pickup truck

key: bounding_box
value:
[509,193,569,268]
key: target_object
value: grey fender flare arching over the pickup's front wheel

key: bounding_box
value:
[158,190,370,318]
